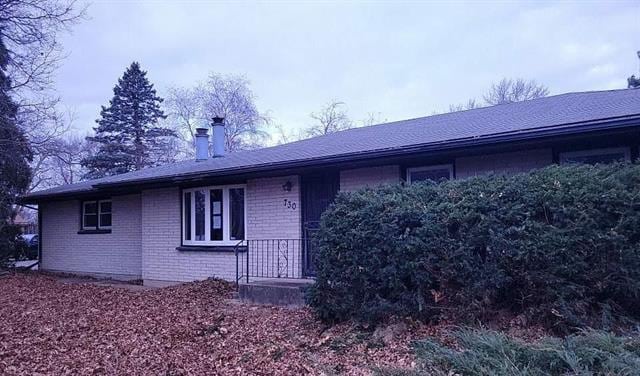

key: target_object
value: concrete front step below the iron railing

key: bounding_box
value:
[237,279,314,308]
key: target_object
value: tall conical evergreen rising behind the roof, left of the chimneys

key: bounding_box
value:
[82,62,176,179]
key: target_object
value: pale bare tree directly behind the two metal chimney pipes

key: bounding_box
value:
[165,73,270,159]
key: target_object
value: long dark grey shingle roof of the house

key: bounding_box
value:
[26,89,640,199]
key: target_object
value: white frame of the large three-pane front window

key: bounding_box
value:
[180,184,248,246]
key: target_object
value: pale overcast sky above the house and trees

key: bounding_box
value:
[57,0,640,138]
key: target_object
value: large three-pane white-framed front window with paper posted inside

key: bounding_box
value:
[182,185,246,246]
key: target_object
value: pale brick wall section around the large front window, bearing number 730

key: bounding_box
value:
[142,176,301,285]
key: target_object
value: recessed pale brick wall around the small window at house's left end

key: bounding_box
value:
[40,195,142,279]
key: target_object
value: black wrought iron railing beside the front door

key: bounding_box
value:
[235,239,306,283]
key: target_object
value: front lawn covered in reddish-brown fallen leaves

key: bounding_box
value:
[0,274,431,375]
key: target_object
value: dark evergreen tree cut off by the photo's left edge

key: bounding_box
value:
[0,30,32,267]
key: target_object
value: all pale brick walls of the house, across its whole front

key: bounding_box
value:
[42,149,552,285]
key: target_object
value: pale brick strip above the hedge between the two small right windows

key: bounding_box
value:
[456,149,553,178]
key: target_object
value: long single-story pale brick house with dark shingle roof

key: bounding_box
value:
[24,90,640,285]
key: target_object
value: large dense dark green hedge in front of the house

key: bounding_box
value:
[309,164,640,331]
